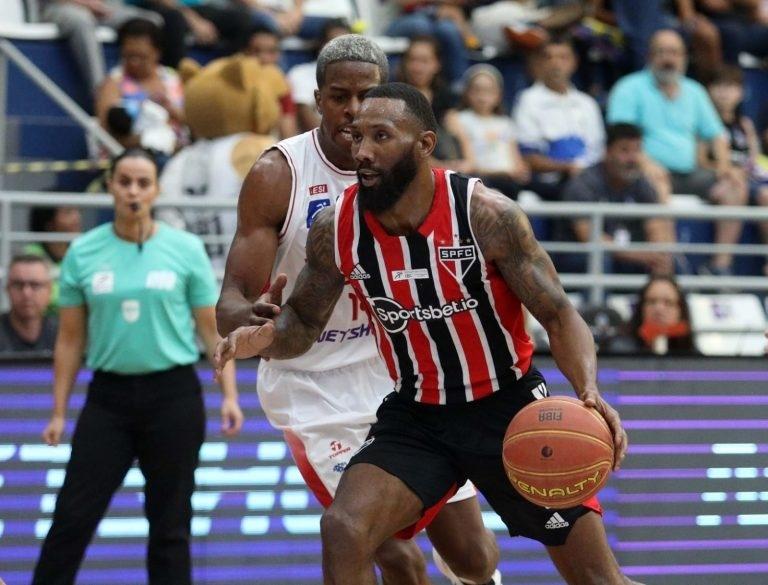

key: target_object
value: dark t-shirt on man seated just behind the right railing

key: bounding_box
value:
[562,163,659,242]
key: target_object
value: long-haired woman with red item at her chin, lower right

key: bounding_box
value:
[629,275,696,355]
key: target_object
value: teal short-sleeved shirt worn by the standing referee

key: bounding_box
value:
[59,223,218,374]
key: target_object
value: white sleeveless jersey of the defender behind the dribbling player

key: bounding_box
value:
[261,129,378,371]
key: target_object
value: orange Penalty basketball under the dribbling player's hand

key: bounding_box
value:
[503,396,613,509]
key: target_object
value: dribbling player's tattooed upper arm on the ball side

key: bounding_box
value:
[471,186,570,324]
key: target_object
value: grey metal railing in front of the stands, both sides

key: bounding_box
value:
[0,191,768,303]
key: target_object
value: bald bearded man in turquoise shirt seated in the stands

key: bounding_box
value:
[608,30,747,275]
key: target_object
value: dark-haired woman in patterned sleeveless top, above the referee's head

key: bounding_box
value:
[96,18,188,155]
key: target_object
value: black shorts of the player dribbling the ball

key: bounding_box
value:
[348,366,602,546]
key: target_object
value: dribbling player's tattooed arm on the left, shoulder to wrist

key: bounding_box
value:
[263,207,344,359]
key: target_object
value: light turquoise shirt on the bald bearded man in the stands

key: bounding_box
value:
[607,69,725,173]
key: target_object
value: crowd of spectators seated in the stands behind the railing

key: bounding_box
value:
[0,0,768,351]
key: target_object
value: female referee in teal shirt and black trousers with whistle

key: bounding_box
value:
[33,149,243,585]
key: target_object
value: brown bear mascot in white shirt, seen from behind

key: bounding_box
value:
[157,55,289,271]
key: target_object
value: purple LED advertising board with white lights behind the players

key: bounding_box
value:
[0,358,768,585]
